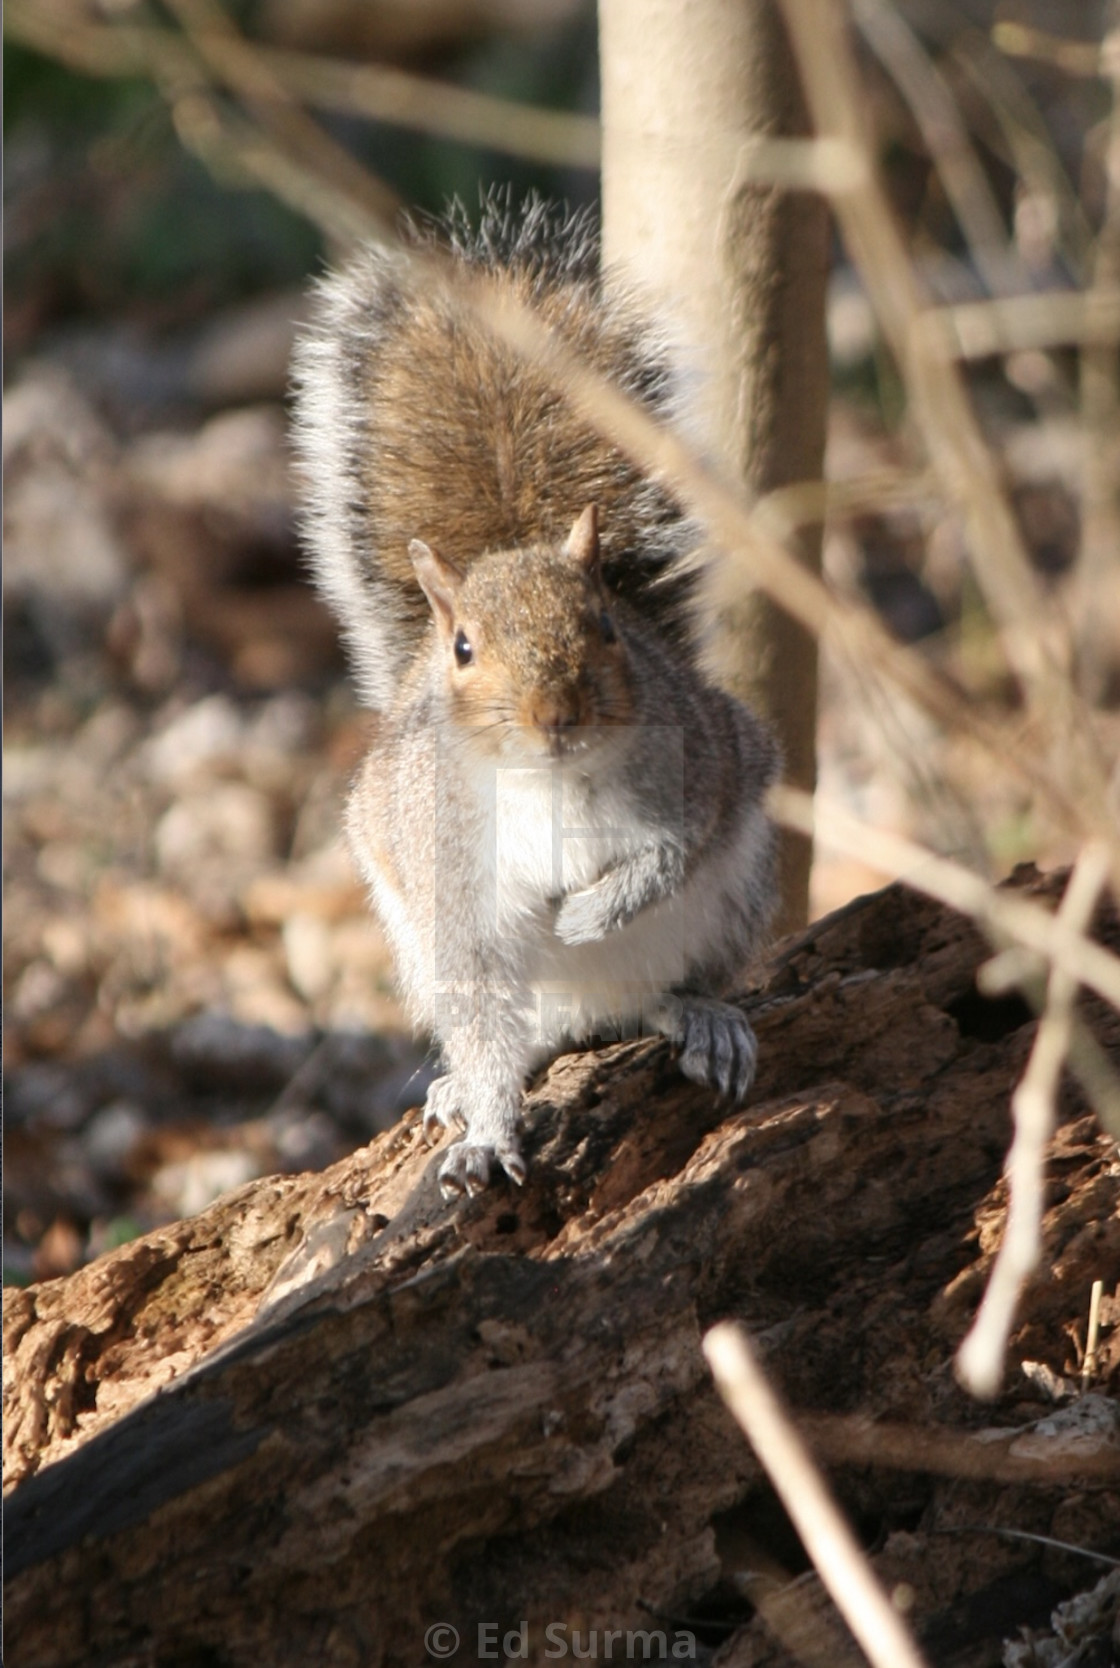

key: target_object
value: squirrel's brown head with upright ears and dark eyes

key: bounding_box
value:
[409,504,634,757]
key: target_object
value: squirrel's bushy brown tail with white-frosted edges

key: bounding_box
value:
[294,193,696,709]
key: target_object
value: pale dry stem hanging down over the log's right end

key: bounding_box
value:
[956,844,1110,1396]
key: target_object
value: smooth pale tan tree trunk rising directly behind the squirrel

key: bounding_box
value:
[599,0,828,931]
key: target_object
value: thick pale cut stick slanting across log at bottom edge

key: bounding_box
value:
[703,1321,923,1668]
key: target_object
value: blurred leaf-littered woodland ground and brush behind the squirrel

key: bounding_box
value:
[3,0,1120,1281]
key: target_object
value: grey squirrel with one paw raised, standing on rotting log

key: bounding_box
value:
[294,197,779,1198]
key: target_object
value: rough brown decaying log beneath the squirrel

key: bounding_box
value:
[5,871,1120,1668]
